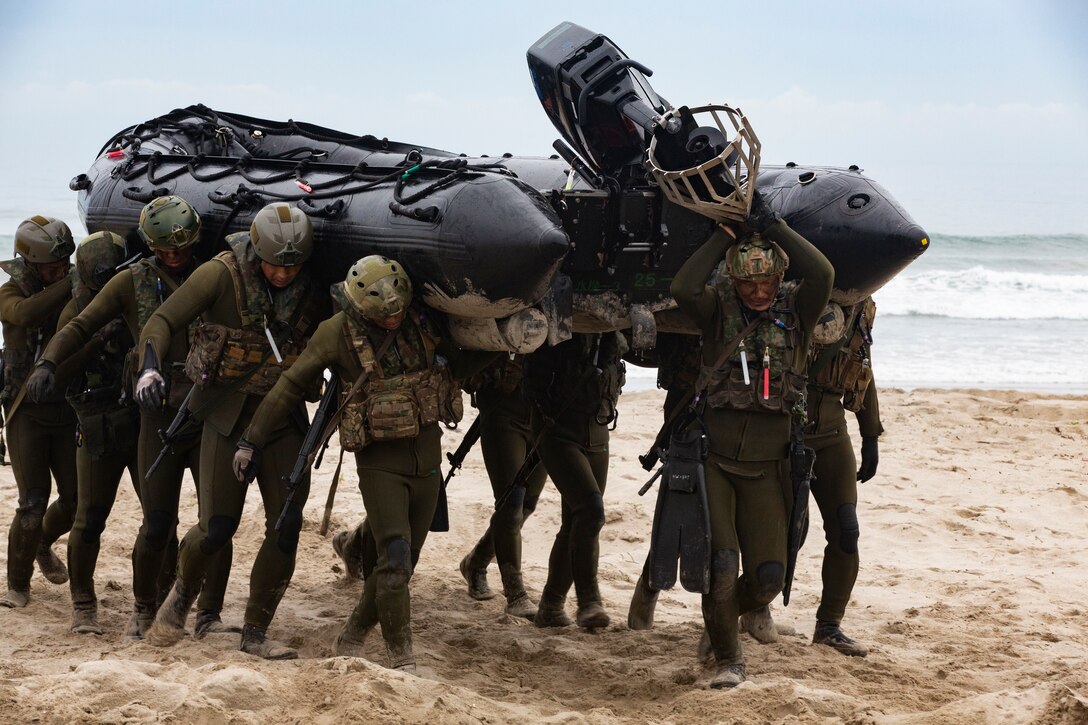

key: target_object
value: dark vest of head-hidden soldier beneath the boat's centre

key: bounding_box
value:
[524,332,628,425]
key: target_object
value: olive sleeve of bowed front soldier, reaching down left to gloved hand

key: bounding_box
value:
[244,315,341,447]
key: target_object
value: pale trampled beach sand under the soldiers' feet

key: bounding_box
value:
[0,390,1088,724]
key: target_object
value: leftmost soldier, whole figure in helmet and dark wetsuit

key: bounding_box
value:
[0,216,77,607]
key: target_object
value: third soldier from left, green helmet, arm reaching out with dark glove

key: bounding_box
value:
[29,196,238,639]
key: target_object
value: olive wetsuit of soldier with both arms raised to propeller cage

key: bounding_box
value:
[671,222,834,665]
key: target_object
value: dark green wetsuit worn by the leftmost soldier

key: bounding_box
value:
[0,264,78,592]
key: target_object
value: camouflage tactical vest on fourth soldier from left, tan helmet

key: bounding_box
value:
[185,232,314,395]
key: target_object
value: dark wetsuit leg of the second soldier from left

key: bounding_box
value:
[67,440,138,611]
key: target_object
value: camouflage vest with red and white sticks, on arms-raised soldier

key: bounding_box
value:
[700,277,806,413]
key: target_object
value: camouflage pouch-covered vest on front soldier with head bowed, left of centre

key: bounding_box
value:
[339,307,465,451]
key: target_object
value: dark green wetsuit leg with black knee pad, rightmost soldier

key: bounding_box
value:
[808,422,860,624]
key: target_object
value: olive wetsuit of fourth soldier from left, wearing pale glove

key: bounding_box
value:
[137,247,316,629]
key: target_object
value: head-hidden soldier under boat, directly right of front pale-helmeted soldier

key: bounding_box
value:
[460,356,547,619]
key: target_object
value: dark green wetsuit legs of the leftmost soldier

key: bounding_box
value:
[8,401,78,591]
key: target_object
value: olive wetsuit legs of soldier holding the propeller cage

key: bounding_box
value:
[703,454,786,665]
